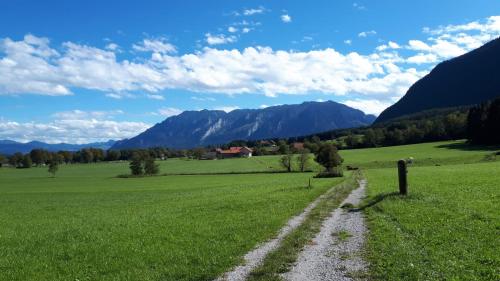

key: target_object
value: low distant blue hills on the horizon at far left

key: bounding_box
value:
[0,140,115,154]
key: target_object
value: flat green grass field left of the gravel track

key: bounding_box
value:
[0,157,341,280]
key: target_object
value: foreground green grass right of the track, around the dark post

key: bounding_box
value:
[365,162,500,280]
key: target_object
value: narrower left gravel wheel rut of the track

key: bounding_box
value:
[215,187,336,281]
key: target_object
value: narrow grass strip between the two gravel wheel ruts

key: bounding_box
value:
[248,173,359,281]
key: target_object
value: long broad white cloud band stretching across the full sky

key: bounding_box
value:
[0,15,500,99]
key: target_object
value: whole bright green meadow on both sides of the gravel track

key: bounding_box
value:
[0,141,500,280]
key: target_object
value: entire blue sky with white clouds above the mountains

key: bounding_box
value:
[0,0,500,143]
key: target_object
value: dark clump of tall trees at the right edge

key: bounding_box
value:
[467,98,500,145]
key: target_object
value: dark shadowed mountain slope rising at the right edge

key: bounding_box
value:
[376,36,500,122]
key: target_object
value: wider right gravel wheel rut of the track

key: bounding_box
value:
[282,180,367,281]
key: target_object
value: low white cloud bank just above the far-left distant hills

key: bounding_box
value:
[0,116,150,144]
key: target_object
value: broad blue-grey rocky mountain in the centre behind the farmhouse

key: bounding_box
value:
[113,101,375,149]
